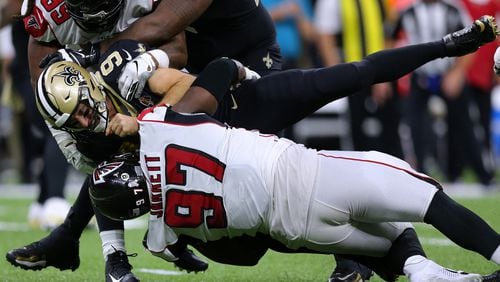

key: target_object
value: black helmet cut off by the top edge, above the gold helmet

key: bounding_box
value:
[66,0,123,33]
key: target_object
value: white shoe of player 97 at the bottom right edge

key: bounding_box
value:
[408,260,483,282]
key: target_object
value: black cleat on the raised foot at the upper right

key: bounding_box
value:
[443,16,499,56]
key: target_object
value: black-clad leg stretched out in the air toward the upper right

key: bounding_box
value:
[231,15,496,133]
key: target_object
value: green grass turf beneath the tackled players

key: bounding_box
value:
[0,189,500,281]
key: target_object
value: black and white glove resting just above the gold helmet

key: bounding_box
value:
[38,45,100,69]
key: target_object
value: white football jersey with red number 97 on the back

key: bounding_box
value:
[139,106,295,252]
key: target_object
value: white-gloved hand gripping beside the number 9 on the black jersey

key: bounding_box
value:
[118,52,156,101]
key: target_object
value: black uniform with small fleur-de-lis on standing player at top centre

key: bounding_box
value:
[186,0,281,75]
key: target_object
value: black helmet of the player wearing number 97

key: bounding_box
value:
[89,156,149,220]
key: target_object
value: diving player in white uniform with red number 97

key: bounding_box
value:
[95,96,500,282]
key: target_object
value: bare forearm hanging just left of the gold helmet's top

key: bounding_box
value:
[28,36,62,89]
